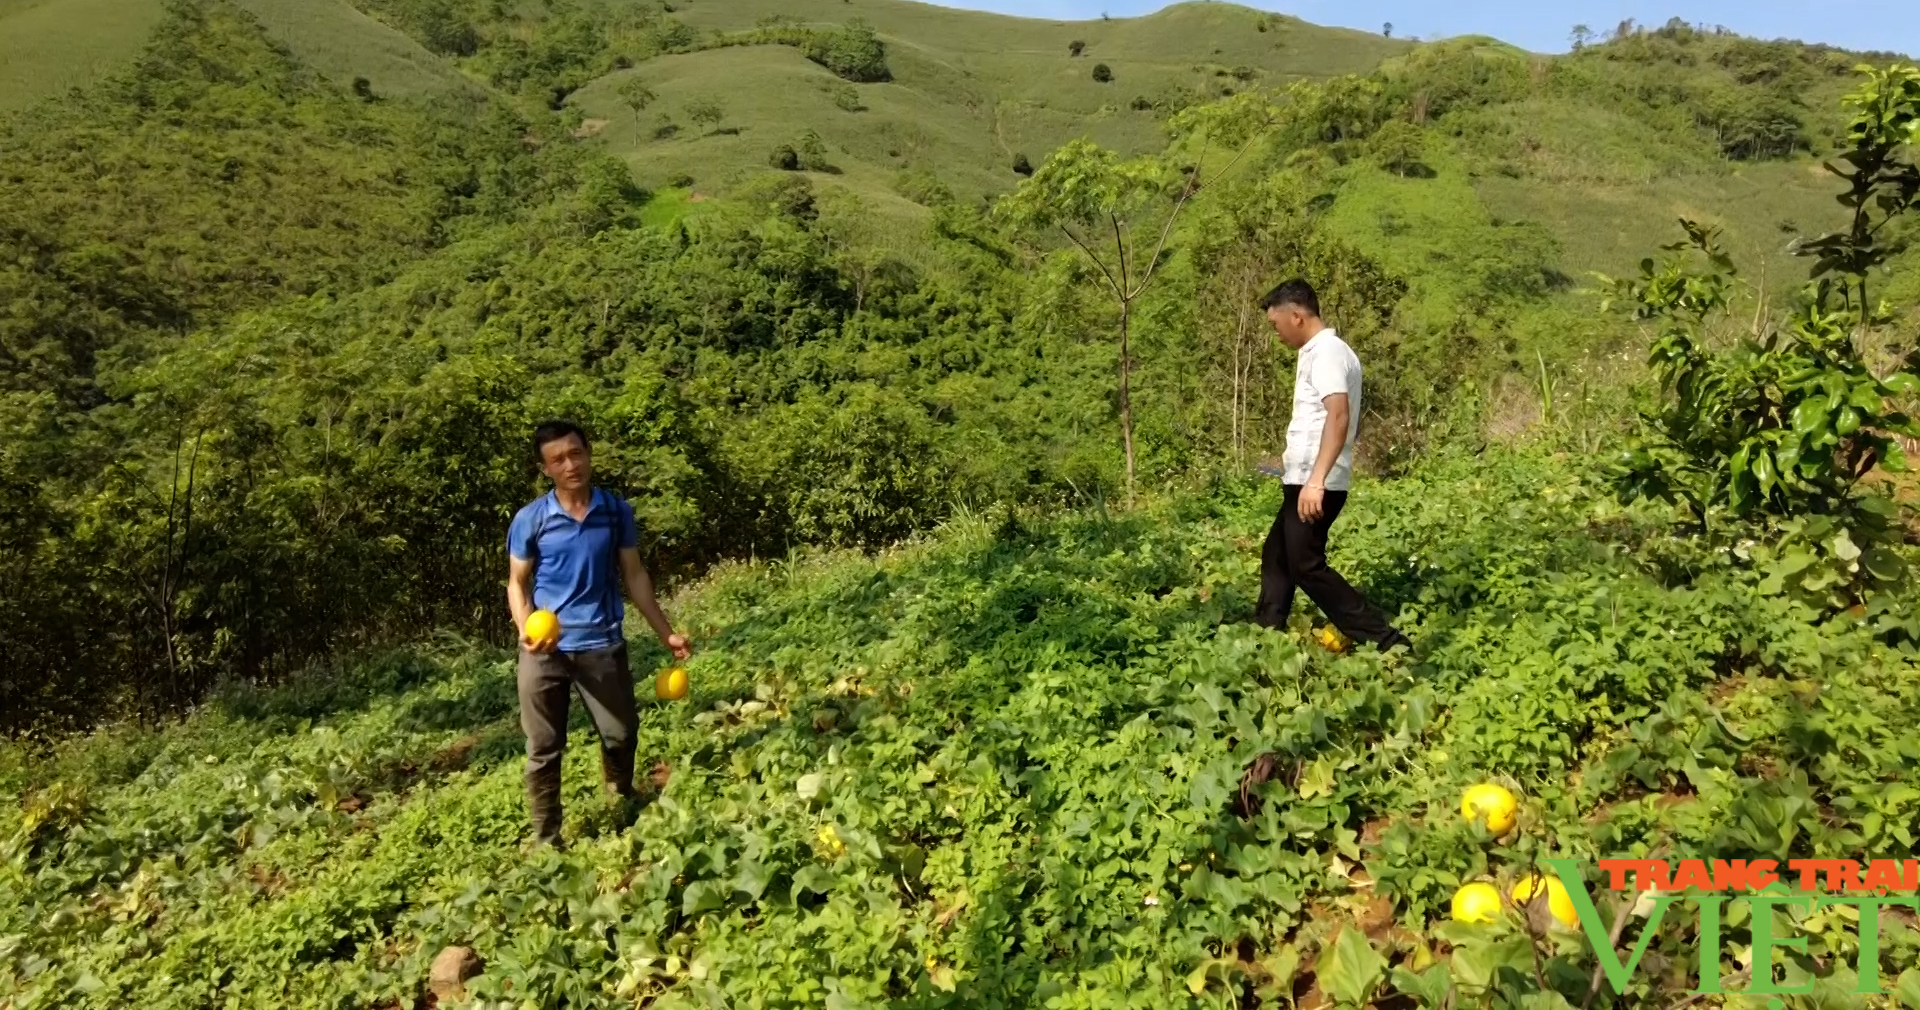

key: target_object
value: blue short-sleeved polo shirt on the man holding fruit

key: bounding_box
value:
[507,488,639,653]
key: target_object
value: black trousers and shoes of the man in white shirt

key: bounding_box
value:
[1254,484,1407,649]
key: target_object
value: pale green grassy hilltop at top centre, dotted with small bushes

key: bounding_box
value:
[570,0,1407,200]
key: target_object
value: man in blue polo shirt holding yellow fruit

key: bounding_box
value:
[507,421,689,843]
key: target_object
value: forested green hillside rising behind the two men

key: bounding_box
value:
[0,0,1912,728]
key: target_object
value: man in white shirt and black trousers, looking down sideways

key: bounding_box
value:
[1254,280,1411,653]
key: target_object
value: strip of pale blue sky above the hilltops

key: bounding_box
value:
[935,0,1920,56]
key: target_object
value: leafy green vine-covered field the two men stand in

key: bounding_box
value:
[15,447,1920,1010]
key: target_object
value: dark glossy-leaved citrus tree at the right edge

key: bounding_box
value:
[1611,67,1920,618]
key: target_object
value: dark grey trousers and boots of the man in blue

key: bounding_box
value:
[518,645,639,841]
